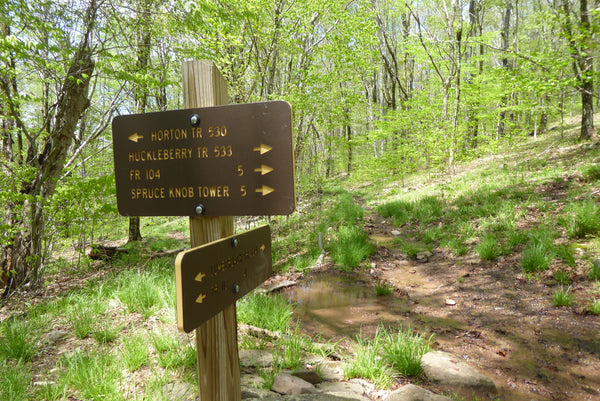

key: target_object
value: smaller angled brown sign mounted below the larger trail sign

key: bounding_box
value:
[175,225,273,333]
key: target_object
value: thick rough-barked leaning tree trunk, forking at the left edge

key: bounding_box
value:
[0,0,97,294]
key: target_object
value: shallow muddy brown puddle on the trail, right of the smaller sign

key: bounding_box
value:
[282,272,409,338]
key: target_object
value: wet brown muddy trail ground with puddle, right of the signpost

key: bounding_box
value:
[276,209,600,401]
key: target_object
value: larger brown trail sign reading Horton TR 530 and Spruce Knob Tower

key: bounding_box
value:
[112,101,296,216]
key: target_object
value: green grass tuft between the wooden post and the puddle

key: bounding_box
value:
[237,293,293,332]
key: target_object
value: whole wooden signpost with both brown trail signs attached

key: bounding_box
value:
[113,61,296,401]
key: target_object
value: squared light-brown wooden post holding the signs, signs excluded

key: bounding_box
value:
[182,61,242,401]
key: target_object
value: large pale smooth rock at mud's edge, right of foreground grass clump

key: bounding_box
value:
[421,351,496,392]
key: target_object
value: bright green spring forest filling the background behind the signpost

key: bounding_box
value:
[0,0,600,294]
